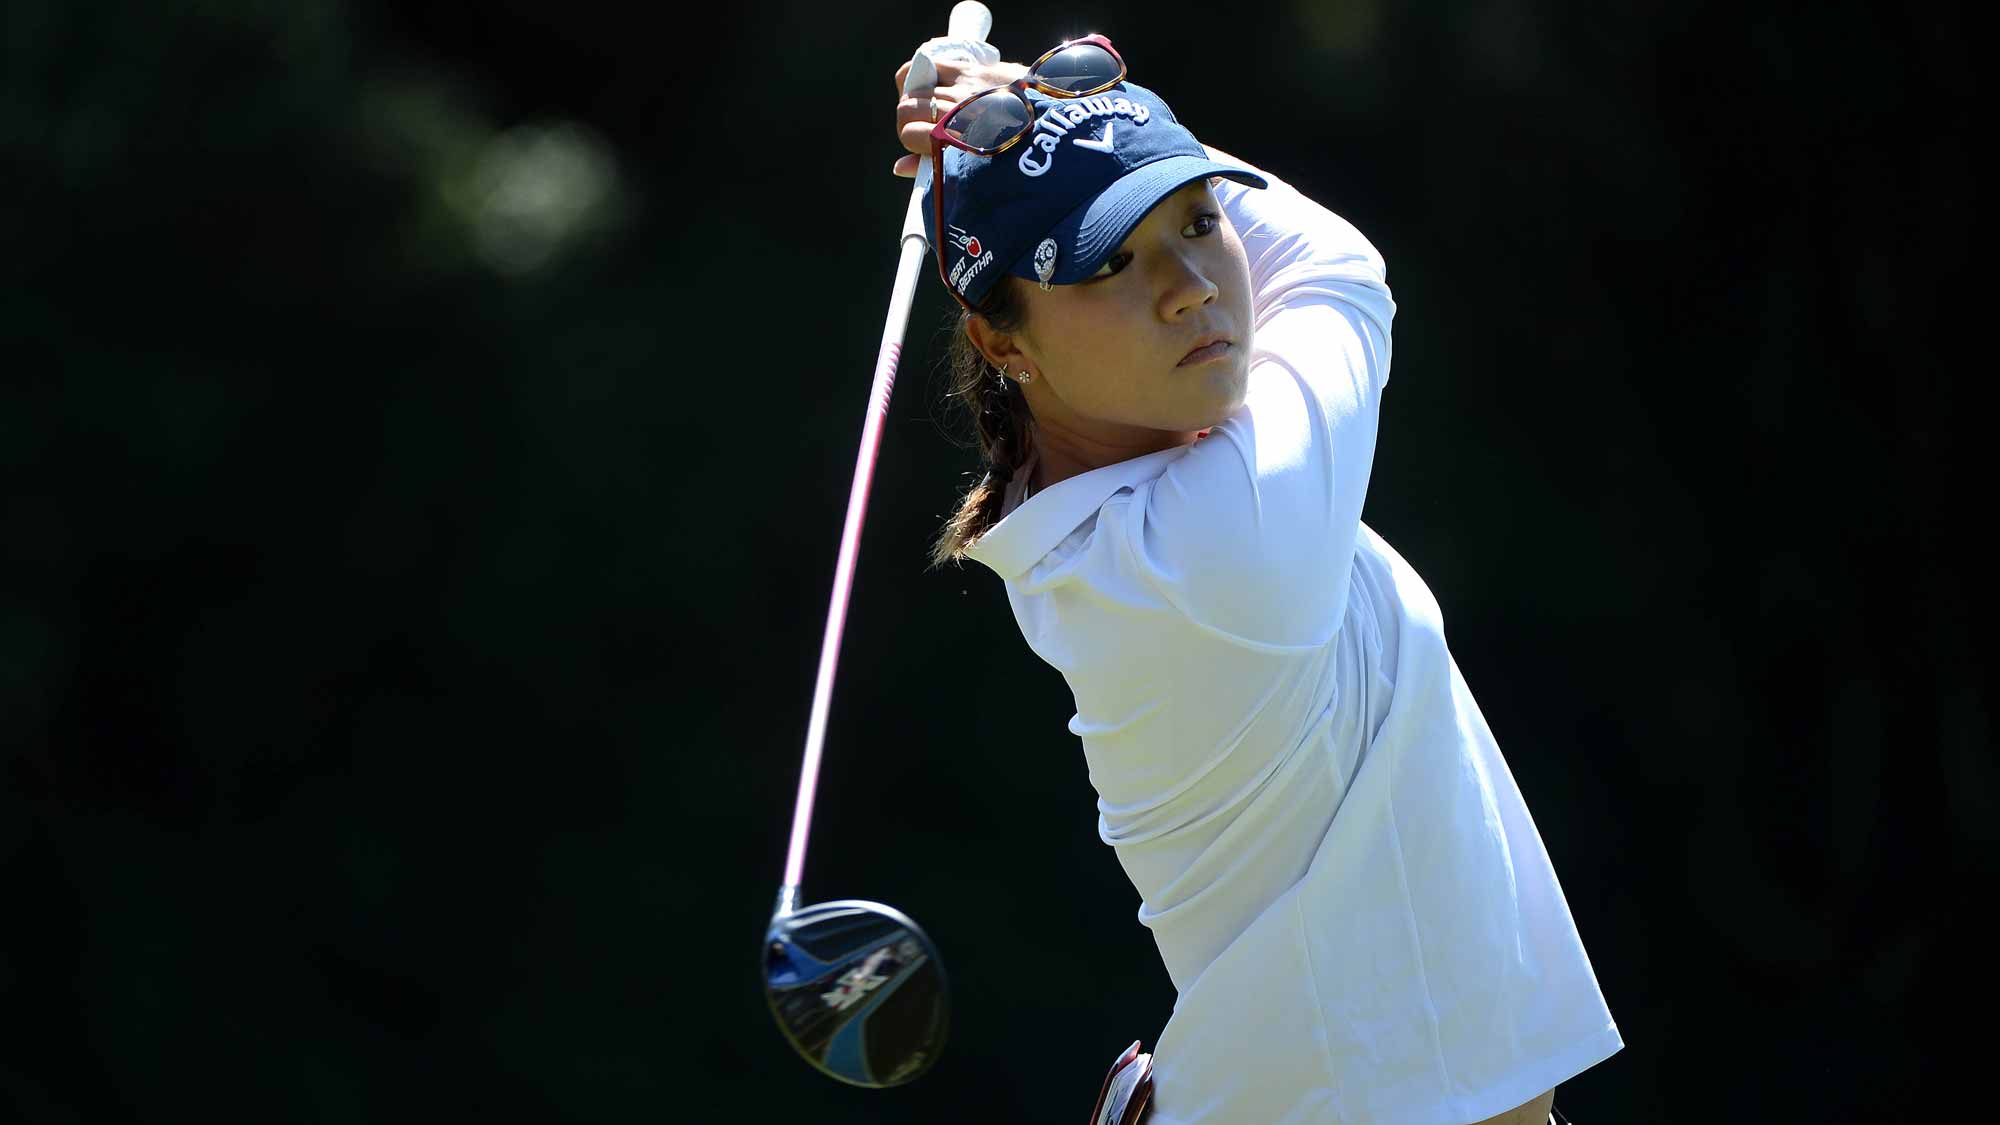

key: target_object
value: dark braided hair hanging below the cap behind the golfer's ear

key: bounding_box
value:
[930,276,1034,569]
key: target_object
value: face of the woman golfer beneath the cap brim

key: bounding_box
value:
[1022,180,1250,434]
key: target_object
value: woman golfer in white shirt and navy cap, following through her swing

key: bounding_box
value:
[896,36,1624,1125]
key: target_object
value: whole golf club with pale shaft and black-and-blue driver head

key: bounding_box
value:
[758,0,992,1089]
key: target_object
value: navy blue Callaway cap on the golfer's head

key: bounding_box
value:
[922,82,1270,304]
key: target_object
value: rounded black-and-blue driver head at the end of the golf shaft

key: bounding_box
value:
[762,897,950,1089]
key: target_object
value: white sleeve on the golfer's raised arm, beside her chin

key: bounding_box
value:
[1128,148,1396,649]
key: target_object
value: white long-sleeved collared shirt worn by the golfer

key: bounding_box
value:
[970,150,1624,1125]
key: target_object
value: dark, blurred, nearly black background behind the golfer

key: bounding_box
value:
[0,0,1976,1125]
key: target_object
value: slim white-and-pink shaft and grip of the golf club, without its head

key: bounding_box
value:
[778,0,992,892]
